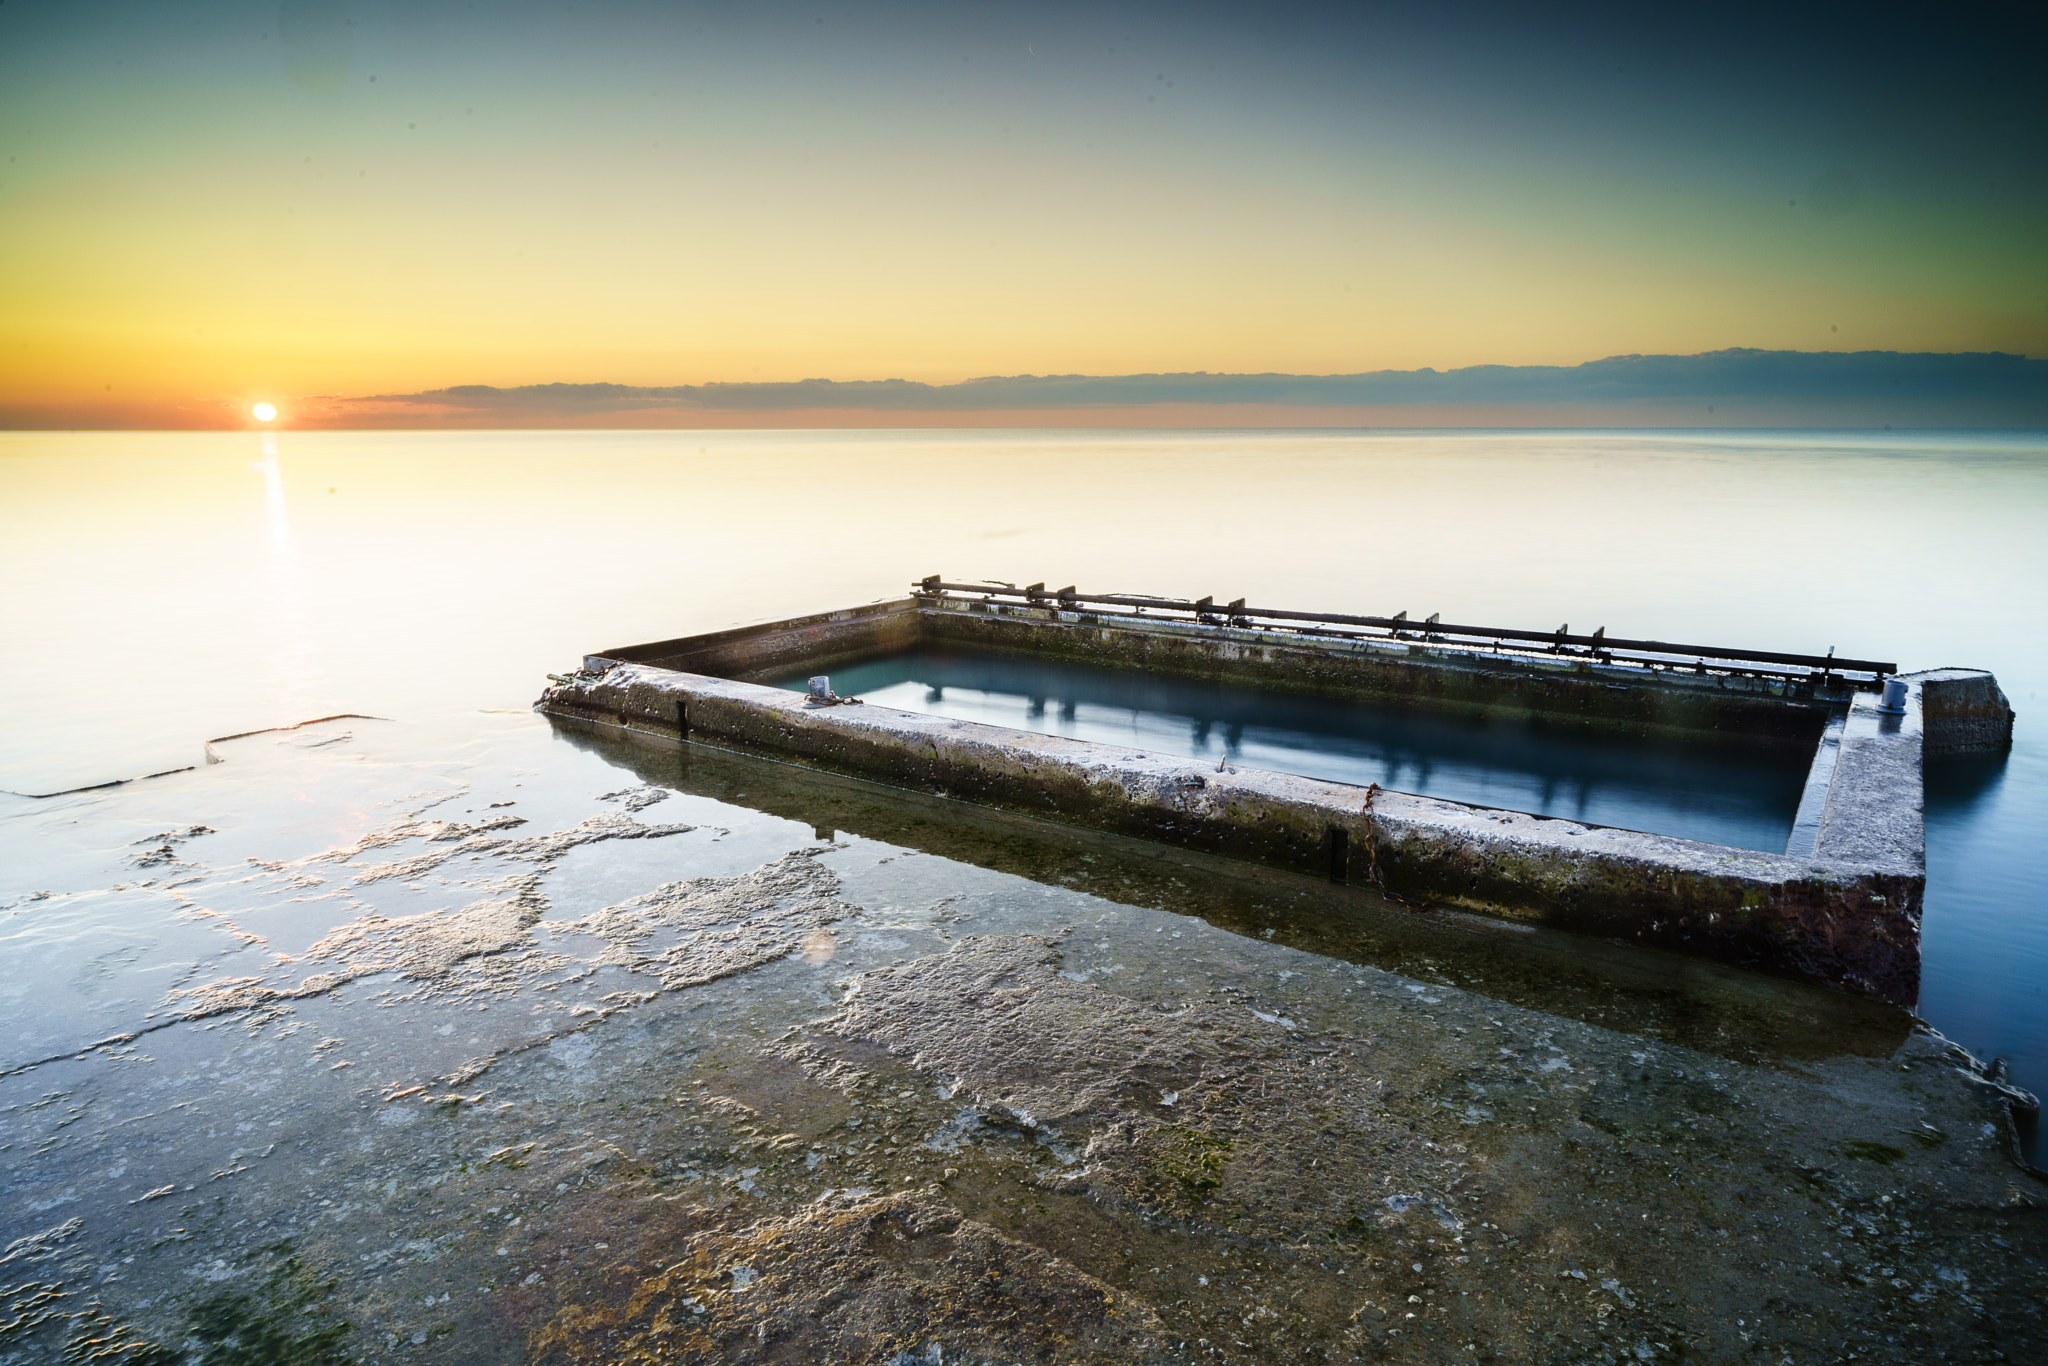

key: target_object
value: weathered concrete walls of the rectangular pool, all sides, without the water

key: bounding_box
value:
[539,598,2003,1004]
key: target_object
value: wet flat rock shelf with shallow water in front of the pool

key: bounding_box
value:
[0,715,2048,1362]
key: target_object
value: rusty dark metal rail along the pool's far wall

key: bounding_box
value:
[911,573,1898,688]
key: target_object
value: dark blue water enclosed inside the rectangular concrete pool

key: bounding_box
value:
[774,649,1808,852]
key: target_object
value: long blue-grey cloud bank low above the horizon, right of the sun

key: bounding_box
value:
[372,350,2048,424]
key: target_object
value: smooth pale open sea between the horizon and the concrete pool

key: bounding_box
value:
[0,432,2048,1087]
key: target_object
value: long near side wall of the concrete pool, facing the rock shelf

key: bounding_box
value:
[541,664,1925,1004]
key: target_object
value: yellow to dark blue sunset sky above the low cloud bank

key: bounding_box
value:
[0,0,2048,426]
